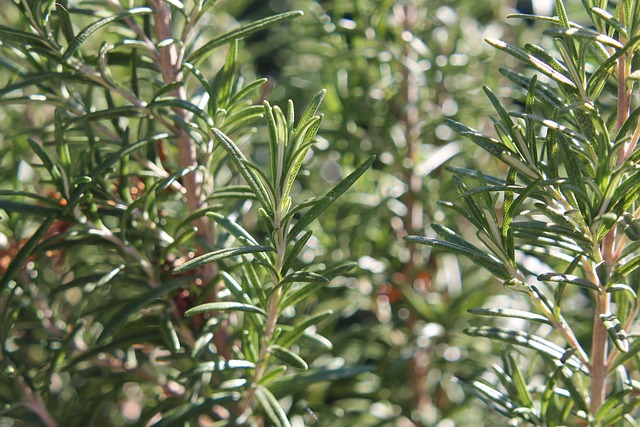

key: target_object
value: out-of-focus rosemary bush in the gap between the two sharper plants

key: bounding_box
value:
[250,0,524,426]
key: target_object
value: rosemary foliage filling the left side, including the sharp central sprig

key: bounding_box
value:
[0,1,375,426]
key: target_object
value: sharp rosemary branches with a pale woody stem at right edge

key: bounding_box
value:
[406,1,640,426]
